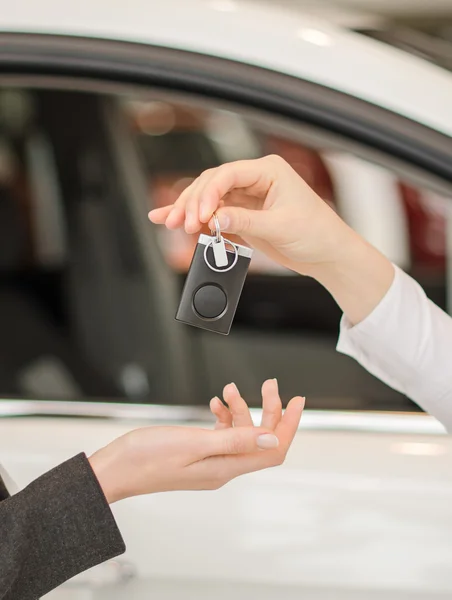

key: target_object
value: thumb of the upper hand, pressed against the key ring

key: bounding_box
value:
[209,206,271,238]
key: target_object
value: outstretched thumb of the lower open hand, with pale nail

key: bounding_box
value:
[208,427,279,456]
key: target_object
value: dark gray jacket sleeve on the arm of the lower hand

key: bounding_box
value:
[0,454,125,600]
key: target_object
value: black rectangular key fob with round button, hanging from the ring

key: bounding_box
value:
[176,234,253,335]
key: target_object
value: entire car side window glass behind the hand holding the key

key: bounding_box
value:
[0,83,450,410]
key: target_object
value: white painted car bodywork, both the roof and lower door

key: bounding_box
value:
[0,0,452,600]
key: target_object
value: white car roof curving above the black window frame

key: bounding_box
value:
[0,0,452,136]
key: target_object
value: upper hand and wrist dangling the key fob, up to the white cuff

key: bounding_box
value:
[149,156,394,324]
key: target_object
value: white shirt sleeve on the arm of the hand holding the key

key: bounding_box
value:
[337,267,452,432]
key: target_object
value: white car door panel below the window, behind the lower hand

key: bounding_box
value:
[0,406,452,600]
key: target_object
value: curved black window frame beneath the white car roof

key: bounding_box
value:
[0,33,452,432]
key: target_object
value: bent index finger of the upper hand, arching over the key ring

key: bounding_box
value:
[199,158,273,223]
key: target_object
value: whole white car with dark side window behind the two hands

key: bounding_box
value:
[0,0,452,600]
